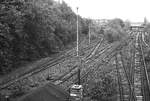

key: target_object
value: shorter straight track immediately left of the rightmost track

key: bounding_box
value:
[115,35,135,101]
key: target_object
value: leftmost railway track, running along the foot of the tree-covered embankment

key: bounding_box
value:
[0,38,99,90]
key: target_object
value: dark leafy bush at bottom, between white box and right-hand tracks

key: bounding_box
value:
[90,74,117,101]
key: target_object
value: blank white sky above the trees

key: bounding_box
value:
[56,0,150,22]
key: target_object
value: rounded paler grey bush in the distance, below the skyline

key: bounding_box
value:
[104,19,127,43]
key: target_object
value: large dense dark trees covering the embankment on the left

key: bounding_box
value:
[0,0,88,74]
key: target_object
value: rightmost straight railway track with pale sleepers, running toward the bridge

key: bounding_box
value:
[131,32,150,101]
